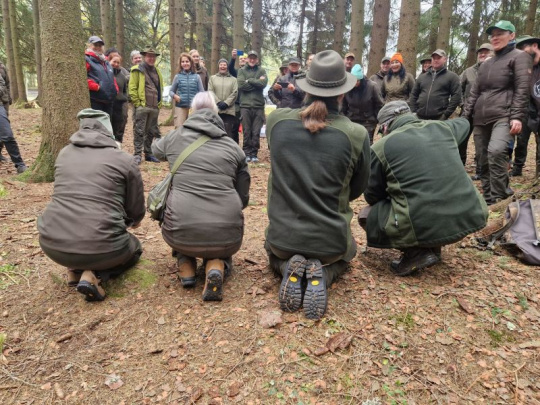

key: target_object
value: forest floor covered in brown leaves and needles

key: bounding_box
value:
[0,105,540,405]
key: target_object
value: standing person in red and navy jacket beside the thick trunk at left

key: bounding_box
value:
[84,35,118,117]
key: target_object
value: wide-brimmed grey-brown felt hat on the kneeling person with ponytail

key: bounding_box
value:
[296,50,356,97]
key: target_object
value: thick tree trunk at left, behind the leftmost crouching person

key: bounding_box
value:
[30,0,90,182]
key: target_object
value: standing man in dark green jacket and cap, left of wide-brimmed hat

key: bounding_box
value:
[238,51,268,163]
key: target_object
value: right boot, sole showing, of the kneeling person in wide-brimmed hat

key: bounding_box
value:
[304,259,328,319]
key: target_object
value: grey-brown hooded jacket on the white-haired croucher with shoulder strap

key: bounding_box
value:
[152,109,250,247]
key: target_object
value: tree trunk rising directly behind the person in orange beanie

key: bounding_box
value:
[397,0,420,76]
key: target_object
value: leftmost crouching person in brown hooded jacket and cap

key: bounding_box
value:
[37,108,145,301]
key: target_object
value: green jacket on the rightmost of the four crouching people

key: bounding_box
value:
[364,114,488,249]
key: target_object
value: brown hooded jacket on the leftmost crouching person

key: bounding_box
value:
[37,118,145,254]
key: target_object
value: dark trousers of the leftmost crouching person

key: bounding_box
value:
[41,233,142,281]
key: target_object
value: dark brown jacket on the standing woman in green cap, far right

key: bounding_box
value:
[463,44,532,125]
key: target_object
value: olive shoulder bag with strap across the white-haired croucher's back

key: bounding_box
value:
[146,135,210,226]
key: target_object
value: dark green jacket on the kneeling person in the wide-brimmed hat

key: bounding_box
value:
[266,102,369,261]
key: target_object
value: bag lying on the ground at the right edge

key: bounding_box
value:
[478,198,540,266]
